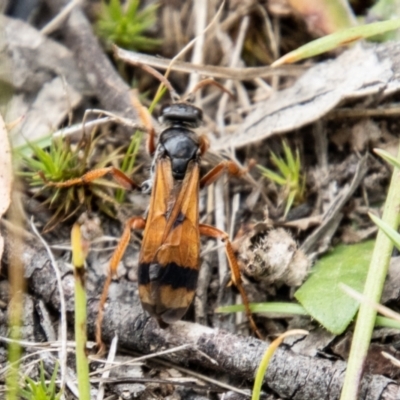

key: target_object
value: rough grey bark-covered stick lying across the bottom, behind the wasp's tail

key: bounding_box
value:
[1,224,400,400]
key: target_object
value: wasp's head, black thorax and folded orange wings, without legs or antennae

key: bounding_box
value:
[138,103,202,327]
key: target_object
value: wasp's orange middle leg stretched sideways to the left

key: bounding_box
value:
[45,167,140,189]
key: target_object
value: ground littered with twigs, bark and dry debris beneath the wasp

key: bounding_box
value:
[0,0,400,400]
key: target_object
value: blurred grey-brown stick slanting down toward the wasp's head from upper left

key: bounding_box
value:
[46,0,137,120]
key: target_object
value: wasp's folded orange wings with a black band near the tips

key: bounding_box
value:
[139,159,200,325]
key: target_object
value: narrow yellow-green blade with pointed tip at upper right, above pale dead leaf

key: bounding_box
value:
[272,18,400,67]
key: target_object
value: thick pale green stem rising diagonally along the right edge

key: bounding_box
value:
[340,142,400,400]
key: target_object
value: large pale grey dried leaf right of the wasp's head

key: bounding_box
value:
[212,44,400,151]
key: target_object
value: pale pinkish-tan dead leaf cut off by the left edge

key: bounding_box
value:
[0,115,13,260]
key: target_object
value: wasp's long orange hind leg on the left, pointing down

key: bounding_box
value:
[96,217,146,354]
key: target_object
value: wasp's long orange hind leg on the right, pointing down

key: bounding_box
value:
[199,224,262,339]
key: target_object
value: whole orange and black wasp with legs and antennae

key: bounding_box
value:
[47,64,260,346]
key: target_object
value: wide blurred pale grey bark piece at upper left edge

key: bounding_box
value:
[0,16,91,147]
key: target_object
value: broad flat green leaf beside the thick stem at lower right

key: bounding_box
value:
[295,241,374,335]
